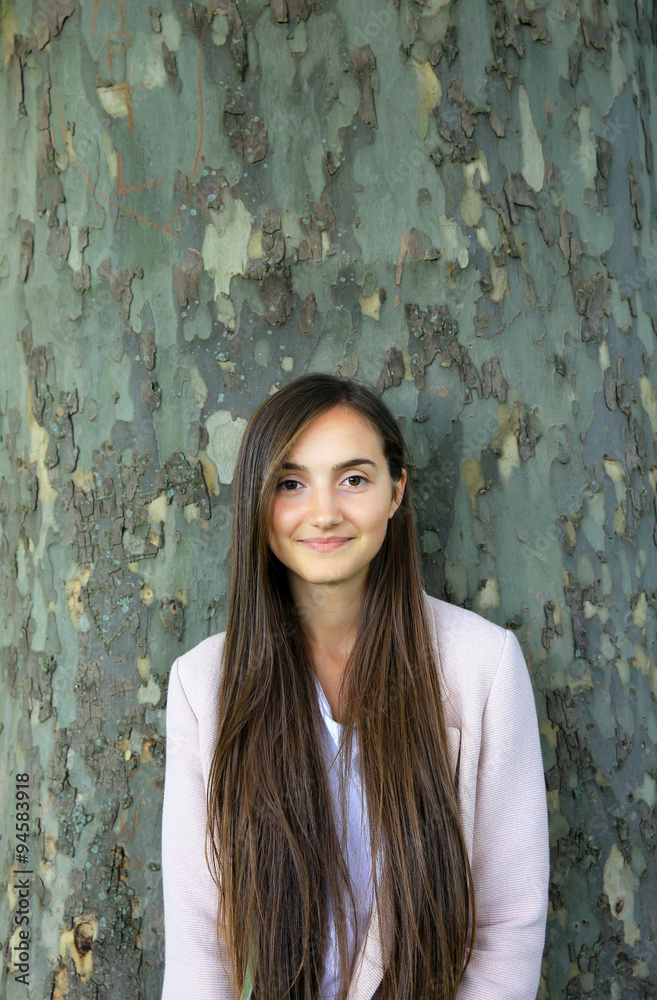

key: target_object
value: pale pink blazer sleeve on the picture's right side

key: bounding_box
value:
[457,629,550,1000]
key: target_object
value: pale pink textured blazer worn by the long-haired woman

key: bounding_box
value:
[162,593,549,1000]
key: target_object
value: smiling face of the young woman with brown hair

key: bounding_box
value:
[269,406,406,584]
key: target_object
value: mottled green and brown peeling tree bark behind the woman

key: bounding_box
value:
[0,0,657,1000]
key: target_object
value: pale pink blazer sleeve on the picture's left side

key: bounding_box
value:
[162,660,238,1000]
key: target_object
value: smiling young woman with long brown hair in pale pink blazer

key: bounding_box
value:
[162,373,549,1000]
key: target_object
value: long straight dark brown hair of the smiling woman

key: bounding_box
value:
[206,373,475,1000]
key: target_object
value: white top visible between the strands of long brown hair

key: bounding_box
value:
[315,677,372,1000]
